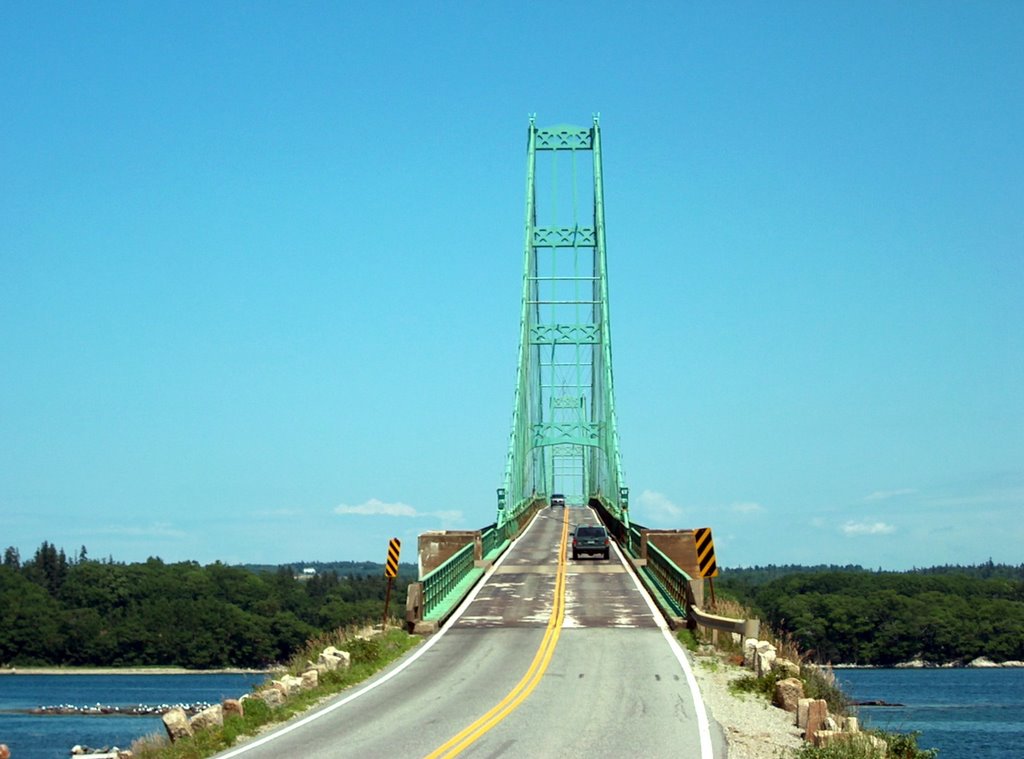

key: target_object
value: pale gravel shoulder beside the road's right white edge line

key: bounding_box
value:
[691,656,804,759]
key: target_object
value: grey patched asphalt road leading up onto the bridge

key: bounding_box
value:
[219,508,726,759]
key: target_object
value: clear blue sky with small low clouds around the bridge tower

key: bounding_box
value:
[0,2,1024,568]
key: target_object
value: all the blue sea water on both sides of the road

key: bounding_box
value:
[0,669,1024,759]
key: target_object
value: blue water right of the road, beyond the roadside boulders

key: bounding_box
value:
[836,668,1024,759]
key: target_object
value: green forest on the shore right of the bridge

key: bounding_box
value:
[716,561,1024,666]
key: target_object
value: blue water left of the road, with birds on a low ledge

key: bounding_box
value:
[0,674,266,759]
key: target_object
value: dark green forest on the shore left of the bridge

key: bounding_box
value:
[0,542,415,669]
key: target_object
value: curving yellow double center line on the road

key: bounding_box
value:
[426,509,569,759]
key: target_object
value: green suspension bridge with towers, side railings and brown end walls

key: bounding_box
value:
[407,117,737,631]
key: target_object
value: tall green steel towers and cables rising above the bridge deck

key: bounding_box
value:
[498,117,629,526]
